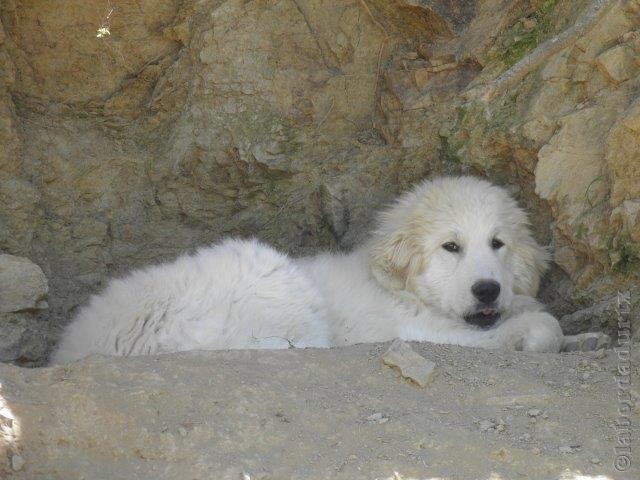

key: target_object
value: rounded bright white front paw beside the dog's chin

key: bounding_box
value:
[501,312,564,353]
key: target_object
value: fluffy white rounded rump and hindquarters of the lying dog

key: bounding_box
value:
[51,240,329,363]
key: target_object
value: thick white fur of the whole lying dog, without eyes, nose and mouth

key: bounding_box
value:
[52,177,563,363]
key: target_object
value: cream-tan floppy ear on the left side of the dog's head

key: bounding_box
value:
[369,212,423,291]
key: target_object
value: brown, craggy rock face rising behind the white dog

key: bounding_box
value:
[0,0,640,360]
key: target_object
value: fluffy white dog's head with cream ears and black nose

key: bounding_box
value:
[369,177,548,327]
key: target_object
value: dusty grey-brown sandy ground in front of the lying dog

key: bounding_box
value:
[0,344,640,480]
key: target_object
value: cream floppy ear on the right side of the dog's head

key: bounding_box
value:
[512,236,549,297]
